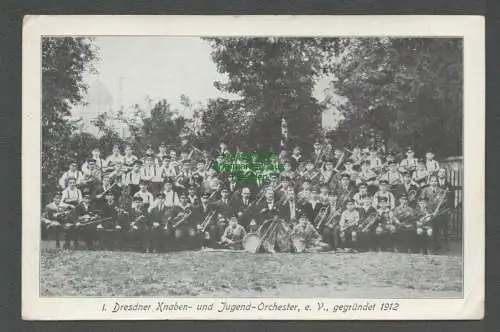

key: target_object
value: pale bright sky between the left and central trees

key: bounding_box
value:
[73,36,340,132]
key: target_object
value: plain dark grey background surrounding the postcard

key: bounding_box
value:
[0,0,500,332]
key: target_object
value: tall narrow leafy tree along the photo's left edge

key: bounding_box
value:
[42,37,97,200]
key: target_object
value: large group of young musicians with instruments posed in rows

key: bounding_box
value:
[42,140,453,253]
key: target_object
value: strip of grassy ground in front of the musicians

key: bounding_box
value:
[40,249,462,298]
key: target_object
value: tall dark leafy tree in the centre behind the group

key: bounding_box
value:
[208,37,339,155]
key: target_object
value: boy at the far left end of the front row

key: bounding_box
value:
[42,192,72,248]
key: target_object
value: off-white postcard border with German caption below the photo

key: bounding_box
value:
[22,16,485,320]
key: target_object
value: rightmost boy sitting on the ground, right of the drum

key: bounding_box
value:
[290,214,328,252]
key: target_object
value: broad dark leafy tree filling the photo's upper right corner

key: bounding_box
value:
[331,38,463,157]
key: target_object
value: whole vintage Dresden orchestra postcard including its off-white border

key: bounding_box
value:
[22,16,485,320]
